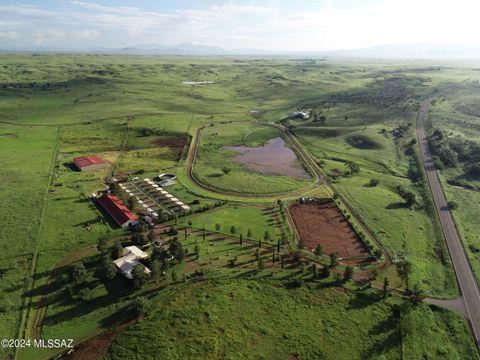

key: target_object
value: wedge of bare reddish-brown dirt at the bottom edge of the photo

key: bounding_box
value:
[61,320,135,360]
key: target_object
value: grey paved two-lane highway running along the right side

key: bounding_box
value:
[417,93,480,348]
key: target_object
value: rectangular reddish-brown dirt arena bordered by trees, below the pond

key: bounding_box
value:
[290,202,369,262]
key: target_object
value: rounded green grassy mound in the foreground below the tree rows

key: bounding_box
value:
[105,280,477,360]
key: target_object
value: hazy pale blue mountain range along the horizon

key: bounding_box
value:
[0,43,480,59]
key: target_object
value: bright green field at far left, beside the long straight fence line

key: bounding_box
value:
[0,125,57,357]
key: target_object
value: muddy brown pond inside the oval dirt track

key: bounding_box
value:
[223,137,310,179]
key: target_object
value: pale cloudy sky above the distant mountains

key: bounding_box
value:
[0,0,480,51]
